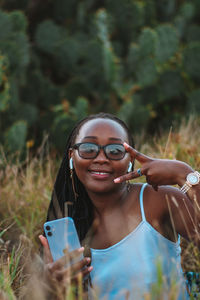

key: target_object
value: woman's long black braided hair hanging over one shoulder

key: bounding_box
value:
[47,112,134,246]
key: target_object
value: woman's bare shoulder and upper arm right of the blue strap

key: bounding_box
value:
[133,184,196,241]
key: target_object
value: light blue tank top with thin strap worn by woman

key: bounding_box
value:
[89,184,188,300]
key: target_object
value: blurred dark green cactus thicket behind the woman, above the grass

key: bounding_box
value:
[0,0,200,153]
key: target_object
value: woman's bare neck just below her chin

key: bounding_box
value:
[88,184,128,216]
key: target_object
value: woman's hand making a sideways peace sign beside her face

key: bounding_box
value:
[114,143,193,190]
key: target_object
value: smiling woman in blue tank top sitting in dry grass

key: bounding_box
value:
[40,113,200,299]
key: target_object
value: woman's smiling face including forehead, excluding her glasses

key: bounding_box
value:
[71,118,131,193]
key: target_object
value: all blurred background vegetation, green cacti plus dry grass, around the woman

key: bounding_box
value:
[0,0,200,300]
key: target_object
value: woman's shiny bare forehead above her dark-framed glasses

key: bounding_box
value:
[76,118,129,142]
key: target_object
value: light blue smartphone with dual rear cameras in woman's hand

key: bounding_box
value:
[44,217,83,262]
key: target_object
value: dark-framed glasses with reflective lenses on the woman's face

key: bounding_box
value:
[72,143,126,160]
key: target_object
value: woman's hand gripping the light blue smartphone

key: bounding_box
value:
[39,235,93,287]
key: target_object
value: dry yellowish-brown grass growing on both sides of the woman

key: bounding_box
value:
[0,118,200,300]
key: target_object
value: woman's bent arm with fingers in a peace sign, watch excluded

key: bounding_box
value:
[115,143,200,246]
